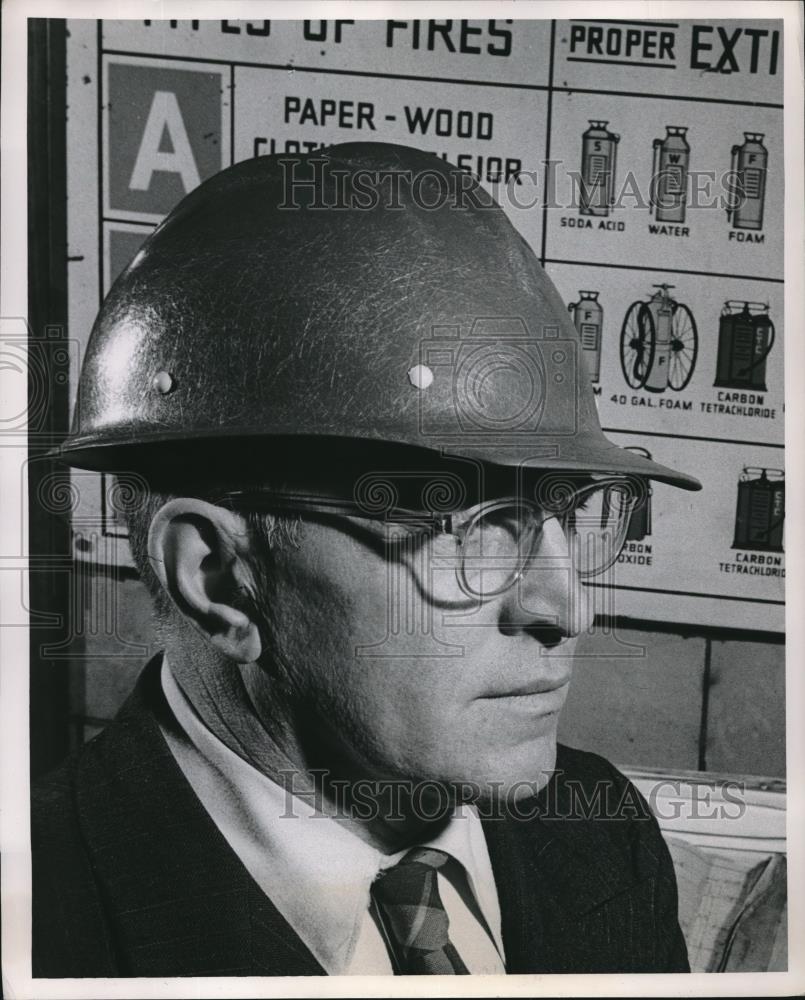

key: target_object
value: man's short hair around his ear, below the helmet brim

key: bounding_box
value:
[118,483,301,624]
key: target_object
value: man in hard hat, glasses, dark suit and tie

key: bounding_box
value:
[34,144,698,976]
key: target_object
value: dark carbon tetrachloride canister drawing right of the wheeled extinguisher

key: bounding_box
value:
[713,299,774,392]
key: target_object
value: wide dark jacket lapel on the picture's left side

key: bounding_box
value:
[76,658,324,976]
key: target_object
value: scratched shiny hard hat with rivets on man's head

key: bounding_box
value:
[61,143,700,489]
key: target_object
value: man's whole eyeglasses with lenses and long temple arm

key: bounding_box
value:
[216,474,648,599]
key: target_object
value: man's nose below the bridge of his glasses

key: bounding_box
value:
[500,518,594,645]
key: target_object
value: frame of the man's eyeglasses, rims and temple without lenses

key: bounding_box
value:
[213,473,649,600]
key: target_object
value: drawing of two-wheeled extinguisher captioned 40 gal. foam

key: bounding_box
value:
[620,285,699,392]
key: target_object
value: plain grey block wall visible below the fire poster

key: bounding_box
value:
[69,574,785,777]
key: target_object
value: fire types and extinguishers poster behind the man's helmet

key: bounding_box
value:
[67,17,785,631]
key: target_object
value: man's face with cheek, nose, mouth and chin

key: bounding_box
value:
[249,484,590,798]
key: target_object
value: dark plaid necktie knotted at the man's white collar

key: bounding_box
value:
[372,847,469,976]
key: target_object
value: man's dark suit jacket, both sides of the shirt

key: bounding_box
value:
[32,658,689,977]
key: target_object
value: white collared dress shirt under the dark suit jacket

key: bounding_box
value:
[162,660,505,975]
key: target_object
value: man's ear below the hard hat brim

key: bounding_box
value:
[148,497,262,663]
